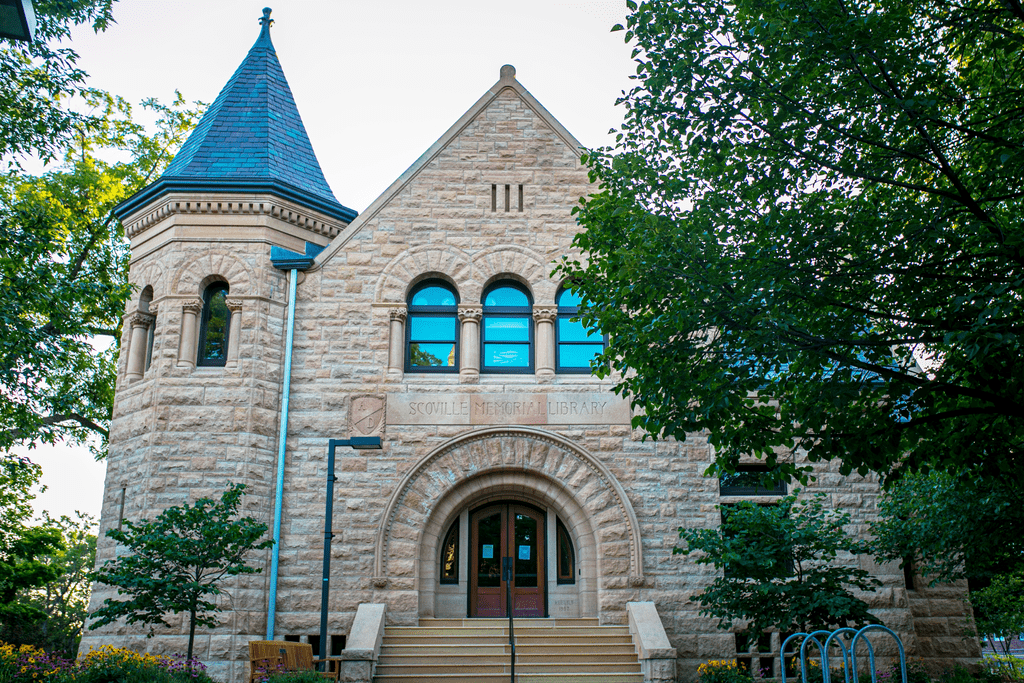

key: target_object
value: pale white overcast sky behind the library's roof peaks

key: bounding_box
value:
[31,0,634,516]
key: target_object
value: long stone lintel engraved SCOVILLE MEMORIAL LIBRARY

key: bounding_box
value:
[387,392,631,425]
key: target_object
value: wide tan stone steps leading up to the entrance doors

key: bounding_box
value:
[374,618,643,683]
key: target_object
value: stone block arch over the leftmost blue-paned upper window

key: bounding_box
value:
[374,245,473,303]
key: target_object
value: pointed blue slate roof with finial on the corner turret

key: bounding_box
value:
[118,8,356,222]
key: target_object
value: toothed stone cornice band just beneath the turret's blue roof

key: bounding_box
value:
[124,195,345,239]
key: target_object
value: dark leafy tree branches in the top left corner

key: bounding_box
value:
[0,0,115,166]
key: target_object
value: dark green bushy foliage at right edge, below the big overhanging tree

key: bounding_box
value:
[871,472,1024,590]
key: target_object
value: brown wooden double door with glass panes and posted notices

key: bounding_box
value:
[469,502,546,616]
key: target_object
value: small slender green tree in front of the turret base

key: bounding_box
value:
[89,484,273,661]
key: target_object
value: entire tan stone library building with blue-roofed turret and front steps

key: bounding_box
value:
[82,11,977,683]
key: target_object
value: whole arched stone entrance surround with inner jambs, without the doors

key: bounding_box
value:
[373,427,643,621]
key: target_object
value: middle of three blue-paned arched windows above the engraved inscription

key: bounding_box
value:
[480,281,534,373]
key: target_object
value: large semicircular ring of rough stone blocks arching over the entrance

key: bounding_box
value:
[374,427,643,587]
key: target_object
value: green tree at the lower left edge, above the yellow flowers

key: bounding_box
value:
[0,459,62,631]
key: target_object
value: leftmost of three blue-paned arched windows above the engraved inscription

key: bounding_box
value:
[406,280,459,373]
